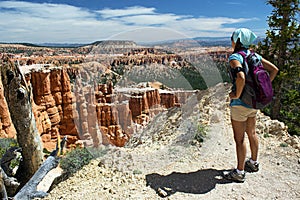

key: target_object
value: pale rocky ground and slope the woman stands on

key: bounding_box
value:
[40,83,300,200]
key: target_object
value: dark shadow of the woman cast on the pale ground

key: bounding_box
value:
[146,169,232,197]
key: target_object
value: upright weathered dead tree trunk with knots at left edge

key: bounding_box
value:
[0,56,43,185]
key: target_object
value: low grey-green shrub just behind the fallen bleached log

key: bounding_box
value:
[60,148,93,174]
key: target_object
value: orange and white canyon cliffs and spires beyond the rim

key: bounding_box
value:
[0,41,229,151]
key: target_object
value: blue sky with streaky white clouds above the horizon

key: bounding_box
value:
[0,0,272,43]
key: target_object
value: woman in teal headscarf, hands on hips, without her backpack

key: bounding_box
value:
[225,28,278,182]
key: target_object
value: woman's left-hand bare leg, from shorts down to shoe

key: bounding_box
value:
[231,119,246,171]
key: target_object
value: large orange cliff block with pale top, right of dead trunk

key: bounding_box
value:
[27,68,78,149]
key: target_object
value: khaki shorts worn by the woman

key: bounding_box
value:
[230,106,257,122]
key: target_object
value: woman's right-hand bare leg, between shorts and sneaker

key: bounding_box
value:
[246,117,259,161]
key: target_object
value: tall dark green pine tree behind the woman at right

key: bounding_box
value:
[259,0,300,123]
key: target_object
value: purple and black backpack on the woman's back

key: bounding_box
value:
[238,51,274,109]
